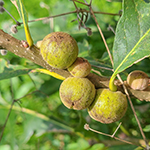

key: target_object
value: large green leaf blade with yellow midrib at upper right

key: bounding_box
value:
[113,0,150,75]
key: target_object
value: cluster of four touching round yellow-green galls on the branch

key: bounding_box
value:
[40,32,149,123]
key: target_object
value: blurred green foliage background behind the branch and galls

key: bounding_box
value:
[0,0,150,150]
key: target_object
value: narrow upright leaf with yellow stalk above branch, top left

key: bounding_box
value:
[11,0,33,46]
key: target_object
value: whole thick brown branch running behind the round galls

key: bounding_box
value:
[0,29,150,101]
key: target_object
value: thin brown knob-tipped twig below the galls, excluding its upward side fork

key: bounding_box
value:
[84,124,144,148]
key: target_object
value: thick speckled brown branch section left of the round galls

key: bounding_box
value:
[0,29,70,77]
